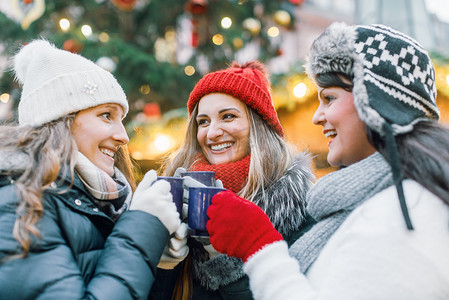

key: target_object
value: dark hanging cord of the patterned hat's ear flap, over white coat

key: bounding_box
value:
[383,122,413,230]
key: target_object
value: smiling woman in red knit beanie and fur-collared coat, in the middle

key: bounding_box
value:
[150,61,314,299]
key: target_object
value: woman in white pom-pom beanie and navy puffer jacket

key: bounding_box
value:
[0,40,181,299]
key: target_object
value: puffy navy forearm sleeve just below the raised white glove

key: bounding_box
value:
[87,211,168,299]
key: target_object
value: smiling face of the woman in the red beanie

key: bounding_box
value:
[196,93,250,165]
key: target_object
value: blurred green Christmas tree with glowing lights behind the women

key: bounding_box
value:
[0,0,302,120]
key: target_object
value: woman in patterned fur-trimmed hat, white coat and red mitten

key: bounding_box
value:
[207,23,449,300]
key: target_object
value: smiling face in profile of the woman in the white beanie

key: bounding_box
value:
[72,103,129,176]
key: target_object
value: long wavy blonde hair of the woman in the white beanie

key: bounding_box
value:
[0,114,135,257]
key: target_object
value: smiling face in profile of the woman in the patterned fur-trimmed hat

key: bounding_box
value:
[312,87,376,166]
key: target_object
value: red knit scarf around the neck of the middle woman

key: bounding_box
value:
[190,155,251,193]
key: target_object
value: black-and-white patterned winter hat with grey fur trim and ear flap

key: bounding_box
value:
[306,23,439,135]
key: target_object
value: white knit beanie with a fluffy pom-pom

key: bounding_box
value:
[14,40,128,126]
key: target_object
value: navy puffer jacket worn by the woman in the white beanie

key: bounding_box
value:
[0,176,169,300]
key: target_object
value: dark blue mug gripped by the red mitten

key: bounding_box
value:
[187,187,226,237]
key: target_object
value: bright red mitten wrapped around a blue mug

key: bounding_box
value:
[207,190,283,262]
